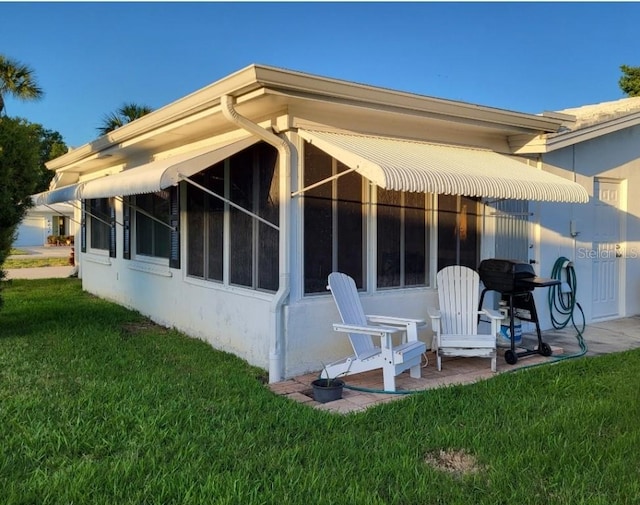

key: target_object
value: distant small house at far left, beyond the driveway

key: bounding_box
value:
[13,203,76,247]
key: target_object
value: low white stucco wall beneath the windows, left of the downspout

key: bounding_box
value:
[82,254,271,369]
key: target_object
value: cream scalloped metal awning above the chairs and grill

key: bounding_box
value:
[298,129,589,203]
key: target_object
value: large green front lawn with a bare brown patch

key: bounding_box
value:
[0,279,640,505]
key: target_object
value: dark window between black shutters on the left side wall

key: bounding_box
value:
[132,191,171,258]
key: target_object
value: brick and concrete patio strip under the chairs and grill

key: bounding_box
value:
[270,316,640,414]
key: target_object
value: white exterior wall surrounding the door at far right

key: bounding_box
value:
[539,126,640,327]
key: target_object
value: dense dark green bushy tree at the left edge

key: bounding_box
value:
[0,116,41,305]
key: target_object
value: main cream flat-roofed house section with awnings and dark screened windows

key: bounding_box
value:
[39,66,588,382]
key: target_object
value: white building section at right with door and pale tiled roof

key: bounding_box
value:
[518,97,640,323]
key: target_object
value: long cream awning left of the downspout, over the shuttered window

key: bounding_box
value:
[80,137,259,199]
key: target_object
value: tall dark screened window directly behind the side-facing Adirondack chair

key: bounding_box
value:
[304,143,365,293]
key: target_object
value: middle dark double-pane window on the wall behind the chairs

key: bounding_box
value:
[377,188,429,288]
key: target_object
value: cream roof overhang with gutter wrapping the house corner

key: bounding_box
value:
[47,65,561,174]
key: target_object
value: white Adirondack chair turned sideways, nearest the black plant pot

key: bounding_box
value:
[328,272,427,391]
